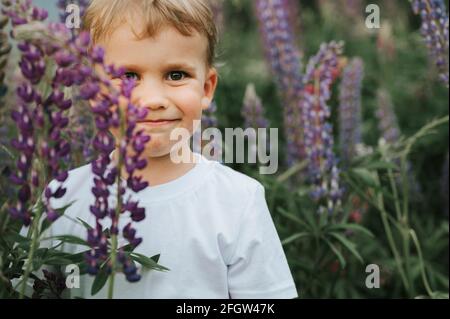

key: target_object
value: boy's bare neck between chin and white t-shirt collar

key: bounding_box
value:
[113,150,195,187]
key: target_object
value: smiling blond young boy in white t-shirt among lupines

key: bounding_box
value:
[46,0,297,298]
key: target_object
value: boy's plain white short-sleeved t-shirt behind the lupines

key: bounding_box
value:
[44,153,298,299]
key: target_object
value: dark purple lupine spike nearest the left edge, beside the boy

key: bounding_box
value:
[3,1,77,226]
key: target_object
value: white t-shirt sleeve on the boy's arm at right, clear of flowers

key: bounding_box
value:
[227,184,298,299]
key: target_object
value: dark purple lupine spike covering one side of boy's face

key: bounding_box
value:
[80,50,150,282]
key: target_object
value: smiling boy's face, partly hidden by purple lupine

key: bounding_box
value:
[98,24,217,157]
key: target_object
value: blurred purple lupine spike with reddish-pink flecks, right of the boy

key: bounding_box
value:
[300,41,342,213]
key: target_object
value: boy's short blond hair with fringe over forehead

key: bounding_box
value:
[83,0,217,66]
